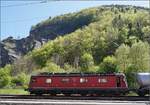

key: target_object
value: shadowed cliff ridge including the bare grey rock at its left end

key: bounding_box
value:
[0,10,94,67]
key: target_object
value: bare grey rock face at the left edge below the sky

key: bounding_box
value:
[0,36,45,67]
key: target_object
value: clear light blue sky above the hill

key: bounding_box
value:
[0,0,149,40]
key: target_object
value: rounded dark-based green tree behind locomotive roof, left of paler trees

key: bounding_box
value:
[99,56,118,73]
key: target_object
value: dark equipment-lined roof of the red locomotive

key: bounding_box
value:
[33,72,124,76]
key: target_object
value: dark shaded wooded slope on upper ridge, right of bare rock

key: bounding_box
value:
[31,8,98,38]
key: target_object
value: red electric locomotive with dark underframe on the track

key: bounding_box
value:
[28,73,128,95]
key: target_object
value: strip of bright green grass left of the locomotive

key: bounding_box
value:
[0,89,29,95]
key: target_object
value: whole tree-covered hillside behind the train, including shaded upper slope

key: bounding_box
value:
[0,5,150,87]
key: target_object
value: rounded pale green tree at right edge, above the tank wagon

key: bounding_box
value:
[129,41,150,72]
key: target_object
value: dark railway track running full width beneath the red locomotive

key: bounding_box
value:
[0,95,150,101]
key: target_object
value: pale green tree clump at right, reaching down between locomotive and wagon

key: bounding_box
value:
[116,41,150,88]
